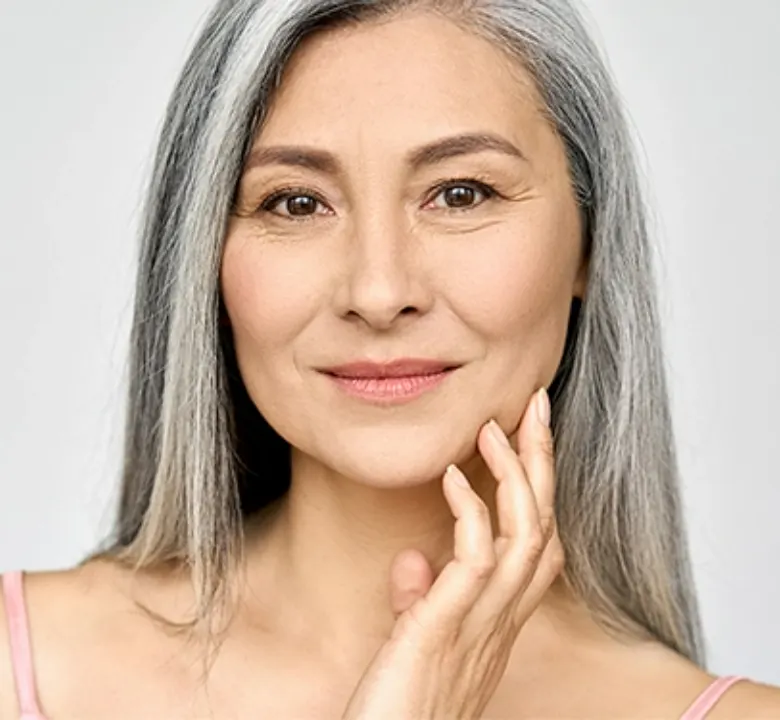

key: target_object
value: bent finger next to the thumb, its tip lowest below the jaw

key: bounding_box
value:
[399,465,496,642]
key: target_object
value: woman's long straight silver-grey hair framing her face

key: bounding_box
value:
[90,0,704,664]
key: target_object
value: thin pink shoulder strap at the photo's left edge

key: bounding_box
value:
[2,570,41,717]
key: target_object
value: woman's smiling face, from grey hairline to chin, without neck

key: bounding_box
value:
[221,13,586,486]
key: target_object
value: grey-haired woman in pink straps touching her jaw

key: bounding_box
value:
[0,0,780,720]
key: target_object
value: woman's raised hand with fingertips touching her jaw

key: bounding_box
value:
[342,393,564,720]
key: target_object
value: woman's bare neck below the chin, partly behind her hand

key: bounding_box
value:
[241,451,596,671]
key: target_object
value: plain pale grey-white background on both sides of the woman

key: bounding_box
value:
[0,0,780,684]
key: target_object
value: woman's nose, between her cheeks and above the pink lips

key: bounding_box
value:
[340,213,432,330]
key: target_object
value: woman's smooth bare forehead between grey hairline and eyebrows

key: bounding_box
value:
[261,11,548,158]
